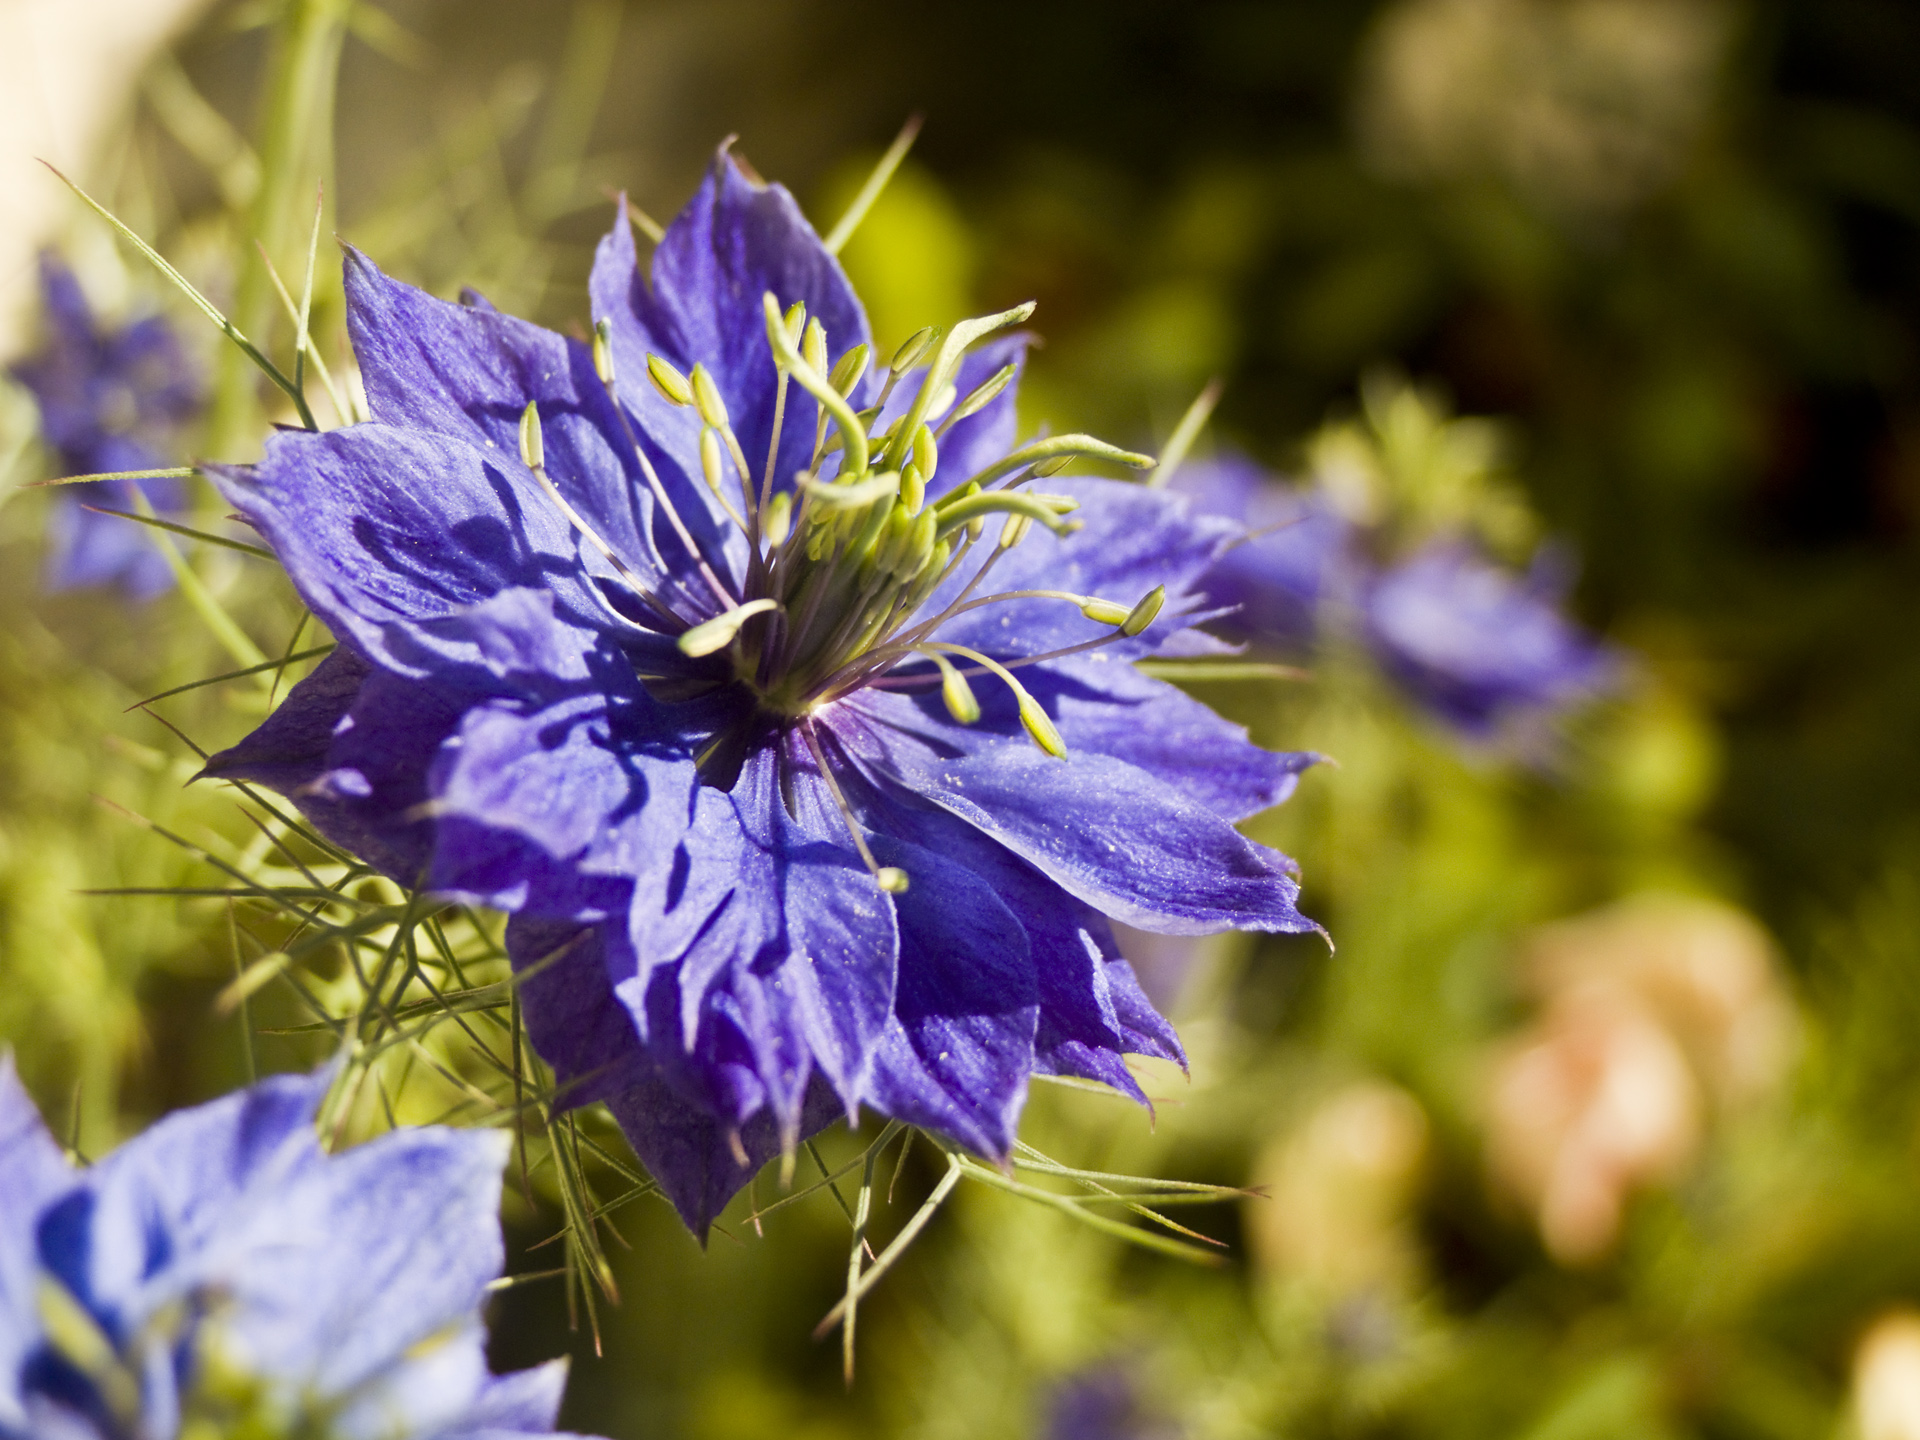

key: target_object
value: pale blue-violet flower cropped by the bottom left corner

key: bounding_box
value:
[0,1054,595,1440]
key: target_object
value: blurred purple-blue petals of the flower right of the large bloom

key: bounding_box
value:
[1171,453,1619,741]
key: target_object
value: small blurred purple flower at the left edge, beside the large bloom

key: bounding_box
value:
[13,253,200,599]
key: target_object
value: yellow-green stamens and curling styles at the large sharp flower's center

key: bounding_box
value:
[520,294,1165,876]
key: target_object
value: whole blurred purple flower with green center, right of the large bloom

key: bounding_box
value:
[1171,384,1619,741]
